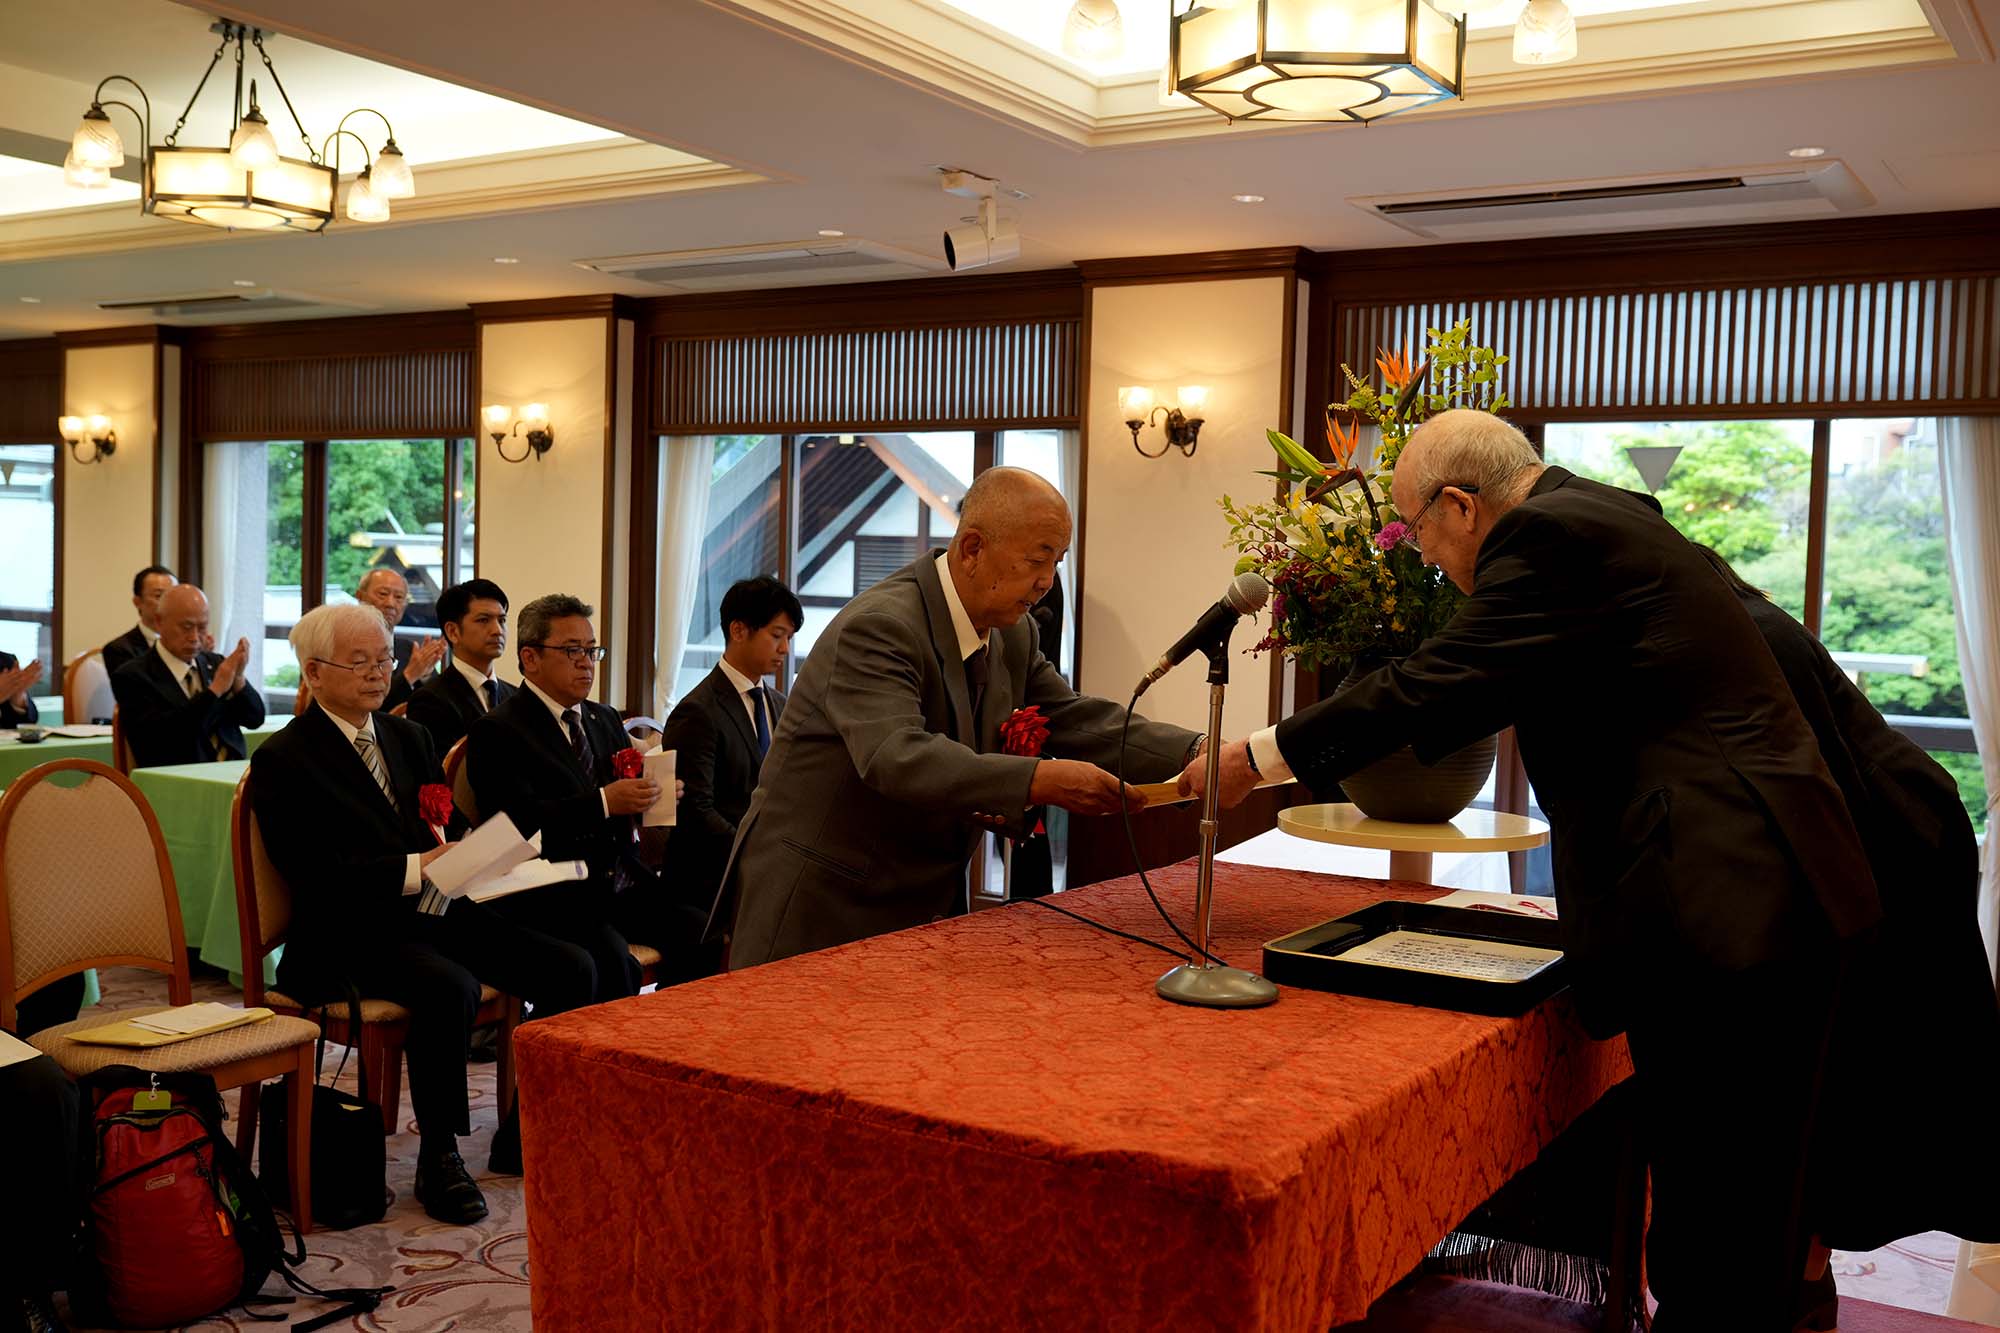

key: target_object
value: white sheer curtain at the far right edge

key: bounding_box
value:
[1938,416,2000,1325]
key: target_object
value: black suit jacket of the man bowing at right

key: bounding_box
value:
[1278,468,1880,1037]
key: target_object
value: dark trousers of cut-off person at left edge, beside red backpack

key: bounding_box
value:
[0,1055,90,1288]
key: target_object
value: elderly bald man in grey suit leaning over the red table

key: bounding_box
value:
[710,468,1202,969]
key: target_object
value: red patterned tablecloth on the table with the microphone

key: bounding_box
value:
[516,865,1630,1333]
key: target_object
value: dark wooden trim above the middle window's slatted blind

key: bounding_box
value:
[638,268,1084,342]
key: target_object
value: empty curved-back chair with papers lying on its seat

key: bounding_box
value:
[0,759,320,1231]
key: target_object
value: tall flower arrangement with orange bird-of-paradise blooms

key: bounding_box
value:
[1222,320,1508,669]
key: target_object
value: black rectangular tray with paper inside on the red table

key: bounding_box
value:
[1264,903,1568,1019]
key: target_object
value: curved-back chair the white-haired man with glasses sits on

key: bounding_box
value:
[230,771,520,1128]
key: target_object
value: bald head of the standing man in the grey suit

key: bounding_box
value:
[950,468,1070,632]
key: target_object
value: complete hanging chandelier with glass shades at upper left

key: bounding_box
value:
[62,20,416,232]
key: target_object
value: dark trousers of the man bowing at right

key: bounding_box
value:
[1626,945,1840,1333]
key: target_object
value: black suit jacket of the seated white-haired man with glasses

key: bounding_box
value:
[250,705,464,999]
